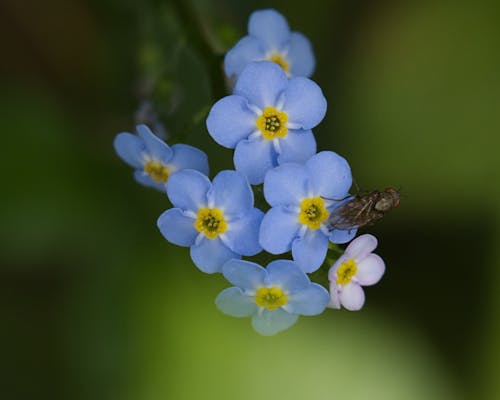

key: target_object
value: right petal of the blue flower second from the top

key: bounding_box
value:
[283,77,326,129]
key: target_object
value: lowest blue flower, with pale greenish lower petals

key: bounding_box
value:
[215,260,330,335]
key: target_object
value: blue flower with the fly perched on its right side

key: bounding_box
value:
[259,151,356,272]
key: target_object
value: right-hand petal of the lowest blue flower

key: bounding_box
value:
[284,283,330,315]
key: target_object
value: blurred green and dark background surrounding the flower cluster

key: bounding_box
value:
[0,0,500,400]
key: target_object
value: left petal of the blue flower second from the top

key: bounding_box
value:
[207,96,257,149]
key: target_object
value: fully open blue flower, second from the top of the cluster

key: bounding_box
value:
[207,61,326,184]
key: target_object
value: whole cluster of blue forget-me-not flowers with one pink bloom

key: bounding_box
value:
[114,10,385,335]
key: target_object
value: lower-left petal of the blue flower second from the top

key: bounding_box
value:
[233,138,278,185]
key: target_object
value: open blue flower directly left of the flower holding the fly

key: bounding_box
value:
[158,169,264,273]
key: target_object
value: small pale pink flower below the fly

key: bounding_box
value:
[328,234,385,311]
